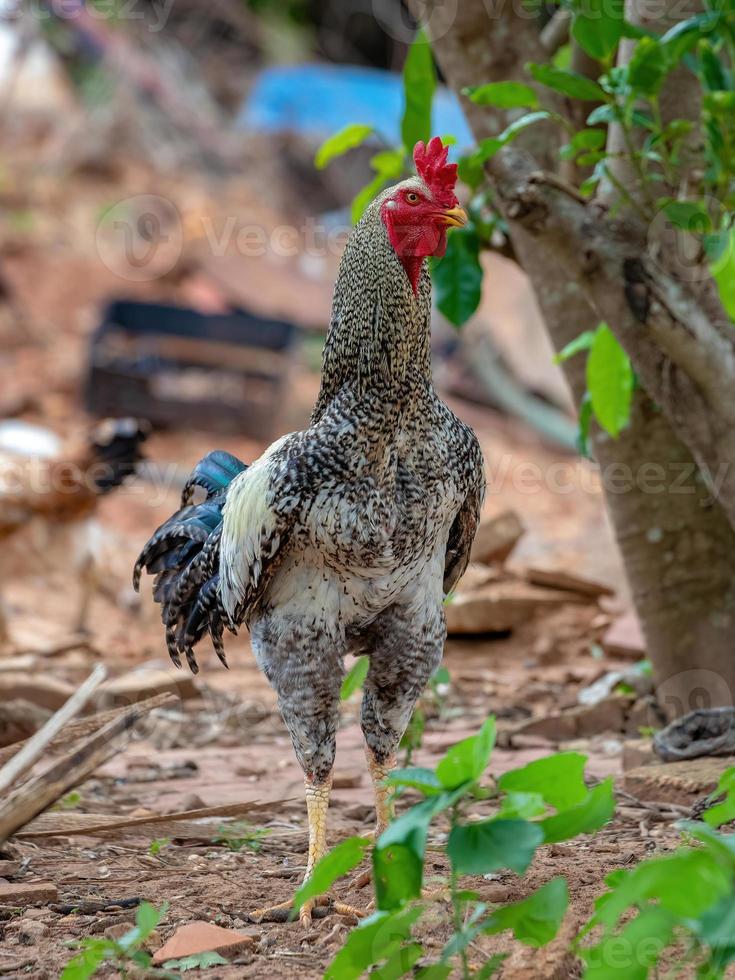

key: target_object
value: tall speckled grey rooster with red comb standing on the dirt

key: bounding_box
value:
[134,137,485,924]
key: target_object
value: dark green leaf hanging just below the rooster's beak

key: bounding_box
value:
[431,225,482,327]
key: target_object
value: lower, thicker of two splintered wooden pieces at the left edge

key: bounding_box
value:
[0,698,167,844]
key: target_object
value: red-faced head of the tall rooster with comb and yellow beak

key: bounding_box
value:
[380,136,467,292]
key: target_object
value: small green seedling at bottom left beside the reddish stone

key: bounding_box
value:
[60,902,172,980]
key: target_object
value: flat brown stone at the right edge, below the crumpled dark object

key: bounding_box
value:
[623,756,735,806]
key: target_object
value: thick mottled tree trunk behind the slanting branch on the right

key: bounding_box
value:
[422,0,735,716]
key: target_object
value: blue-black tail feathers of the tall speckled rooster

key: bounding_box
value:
[133,450,246,674]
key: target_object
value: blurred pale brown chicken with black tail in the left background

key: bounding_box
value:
[0,419,148,642]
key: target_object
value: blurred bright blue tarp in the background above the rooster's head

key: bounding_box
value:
[238,64,474,150]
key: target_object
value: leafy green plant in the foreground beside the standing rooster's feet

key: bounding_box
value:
[295,718,614,980]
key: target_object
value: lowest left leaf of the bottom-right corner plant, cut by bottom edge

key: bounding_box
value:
[580,905,676,980]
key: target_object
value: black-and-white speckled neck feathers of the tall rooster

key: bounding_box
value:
[312,190,431,421]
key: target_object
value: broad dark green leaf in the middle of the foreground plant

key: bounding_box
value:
[447,817,544,875]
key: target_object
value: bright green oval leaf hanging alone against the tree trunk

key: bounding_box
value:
[587,323,633,438]
